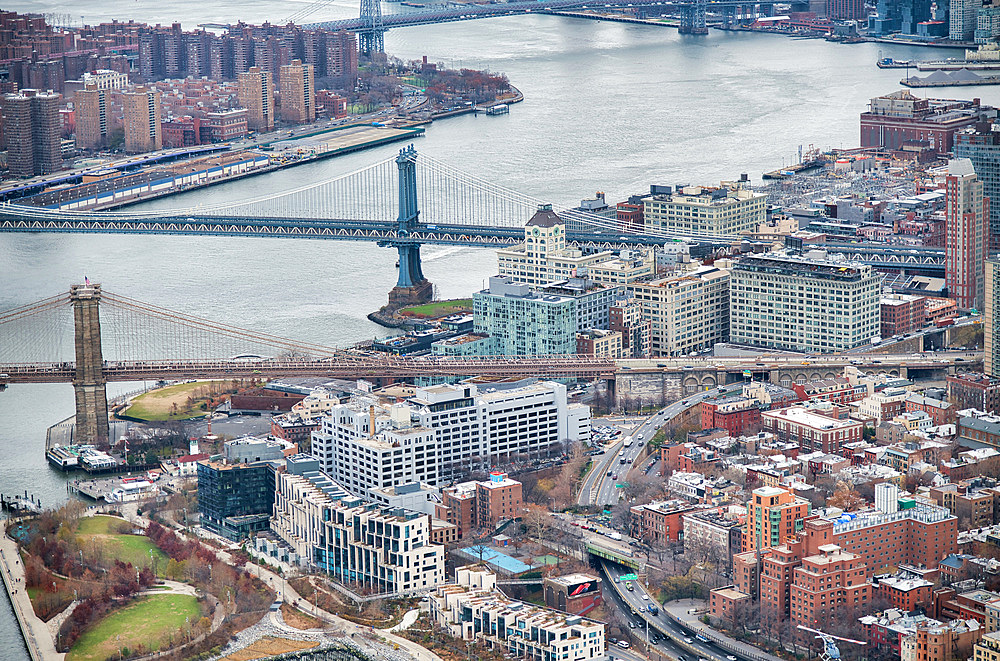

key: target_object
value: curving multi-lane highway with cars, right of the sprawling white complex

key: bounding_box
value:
[577,383,743,505]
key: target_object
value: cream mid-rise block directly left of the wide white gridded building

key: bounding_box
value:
[631,264,730,356]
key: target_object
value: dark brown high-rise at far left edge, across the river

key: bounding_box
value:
[0,89,62,177]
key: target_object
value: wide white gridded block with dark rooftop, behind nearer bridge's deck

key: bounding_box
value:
[729,251,881,353]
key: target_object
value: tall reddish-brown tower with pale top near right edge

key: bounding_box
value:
[945,158,990,310]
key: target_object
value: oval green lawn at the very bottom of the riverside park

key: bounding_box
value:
[66,594,201,661]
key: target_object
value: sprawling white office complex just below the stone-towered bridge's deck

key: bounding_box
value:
[312,381,590,496]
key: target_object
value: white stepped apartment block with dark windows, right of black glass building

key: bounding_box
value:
[271,455,444,594]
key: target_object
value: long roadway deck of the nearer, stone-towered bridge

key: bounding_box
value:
[0,351,981,384]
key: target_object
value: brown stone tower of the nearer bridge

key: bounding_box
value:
[69,284,109,447]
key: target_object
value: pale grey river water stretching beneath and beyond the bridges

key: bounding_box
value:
[0,0,1000,659]
